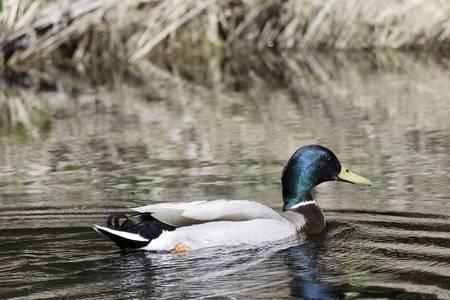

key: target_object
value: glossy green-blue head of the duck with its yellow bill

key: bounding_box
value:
[281,145,371,210]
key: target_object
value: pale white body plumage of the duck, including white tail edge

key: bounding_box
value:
[96,200,305,251]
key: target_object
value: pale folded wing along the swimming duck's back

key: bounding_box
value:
[133,200,282,227]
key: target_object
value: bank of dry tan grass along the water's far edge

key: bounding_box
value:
[0,0,450,69]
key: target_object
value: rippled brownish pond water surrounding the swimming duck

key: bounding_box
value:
[0,54,450,299]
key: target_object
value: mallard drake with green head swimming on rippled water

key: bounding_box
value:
[93,145,372,253]
